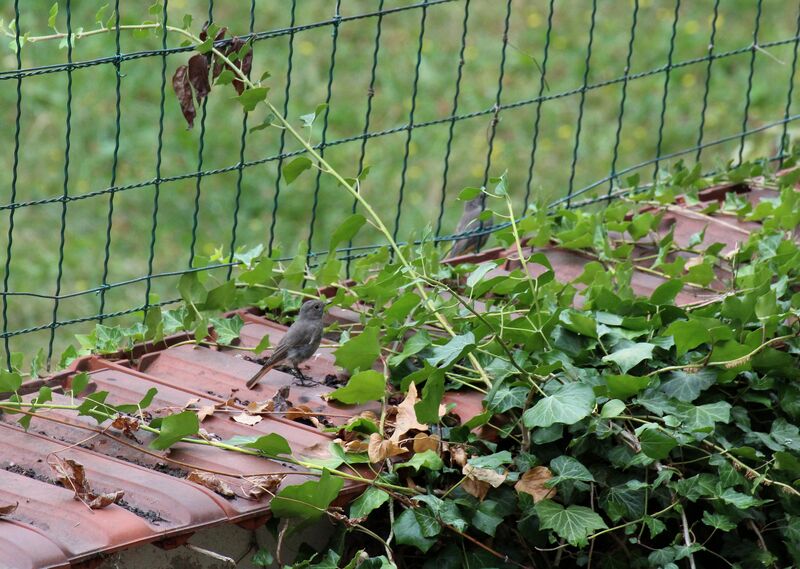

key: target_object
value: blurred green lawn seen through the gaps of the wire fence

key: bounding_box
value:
[0,0,798,362]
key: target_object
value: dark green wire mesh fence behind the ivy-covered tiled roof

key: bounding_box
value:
[0,0,800,368]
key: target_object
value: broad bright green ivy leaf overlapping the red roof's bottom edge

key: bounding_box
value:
[270,468,344,523]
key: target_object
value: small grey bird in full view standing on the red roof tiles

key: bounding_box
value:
[247,300,325,389]
